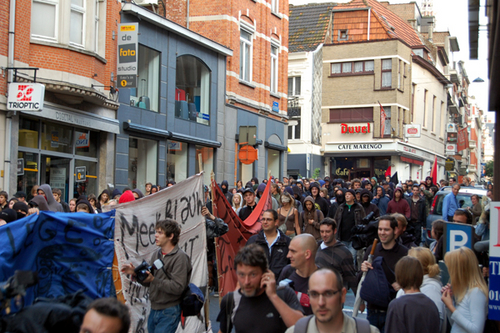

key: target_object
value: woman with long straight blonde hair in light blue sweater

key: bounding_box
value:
[441,247,488,333]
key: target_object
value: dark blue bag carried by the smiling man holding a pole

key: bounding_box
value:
[360,256,396,308]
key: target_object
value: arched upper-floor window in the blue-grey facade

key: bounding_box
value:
[175,55,211,125]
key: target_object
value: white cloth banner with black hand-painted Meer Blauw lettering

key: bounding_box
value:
[114,174,208,332]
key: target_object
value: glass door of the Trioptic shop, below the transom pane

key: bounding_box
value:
[40,155,73,202]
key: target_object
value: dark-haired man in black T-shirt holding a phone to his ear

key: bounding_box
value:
[217,244,303,333]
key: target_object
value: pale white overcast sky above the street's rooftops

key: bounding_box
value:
[289,0,488,110]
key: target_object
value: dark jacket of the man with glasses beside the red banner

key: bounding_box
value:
[247,229,290,277]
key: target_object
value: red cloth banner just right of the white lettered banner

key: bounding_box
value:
[212,179,272,298]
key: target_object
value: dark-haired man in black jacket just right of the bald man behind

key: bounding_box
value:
[316,217,358,295]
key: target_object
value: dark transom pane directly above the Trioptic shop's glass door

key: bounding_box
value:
[41,122,73,154]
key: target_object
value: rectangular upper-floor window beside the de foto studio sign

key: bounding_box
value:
[130,44,160,112]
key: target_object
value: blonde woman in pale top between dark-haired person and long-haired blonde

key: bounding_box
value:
[397,247,446,332]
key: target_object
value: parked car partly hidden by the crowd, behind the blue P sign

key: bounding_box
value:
[424,186,487,246]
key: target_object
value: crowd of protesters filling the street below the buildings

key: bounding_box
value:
[0,177,492,333]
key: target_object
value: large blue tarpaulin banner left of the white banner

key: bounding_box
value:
[0,210,115,305]
